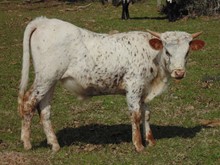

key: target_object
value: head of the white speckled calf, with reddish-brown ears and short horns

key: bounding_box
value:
[148,30,205,79]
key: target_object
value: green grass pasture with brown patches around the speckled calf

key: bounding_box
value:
[0,0,220,165]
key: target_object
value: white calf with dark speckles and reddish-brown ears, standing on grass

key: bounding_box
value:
[18,17,205,151]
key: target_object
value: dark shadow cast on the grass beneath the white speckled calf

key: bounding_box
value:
[38,124,203,147]
